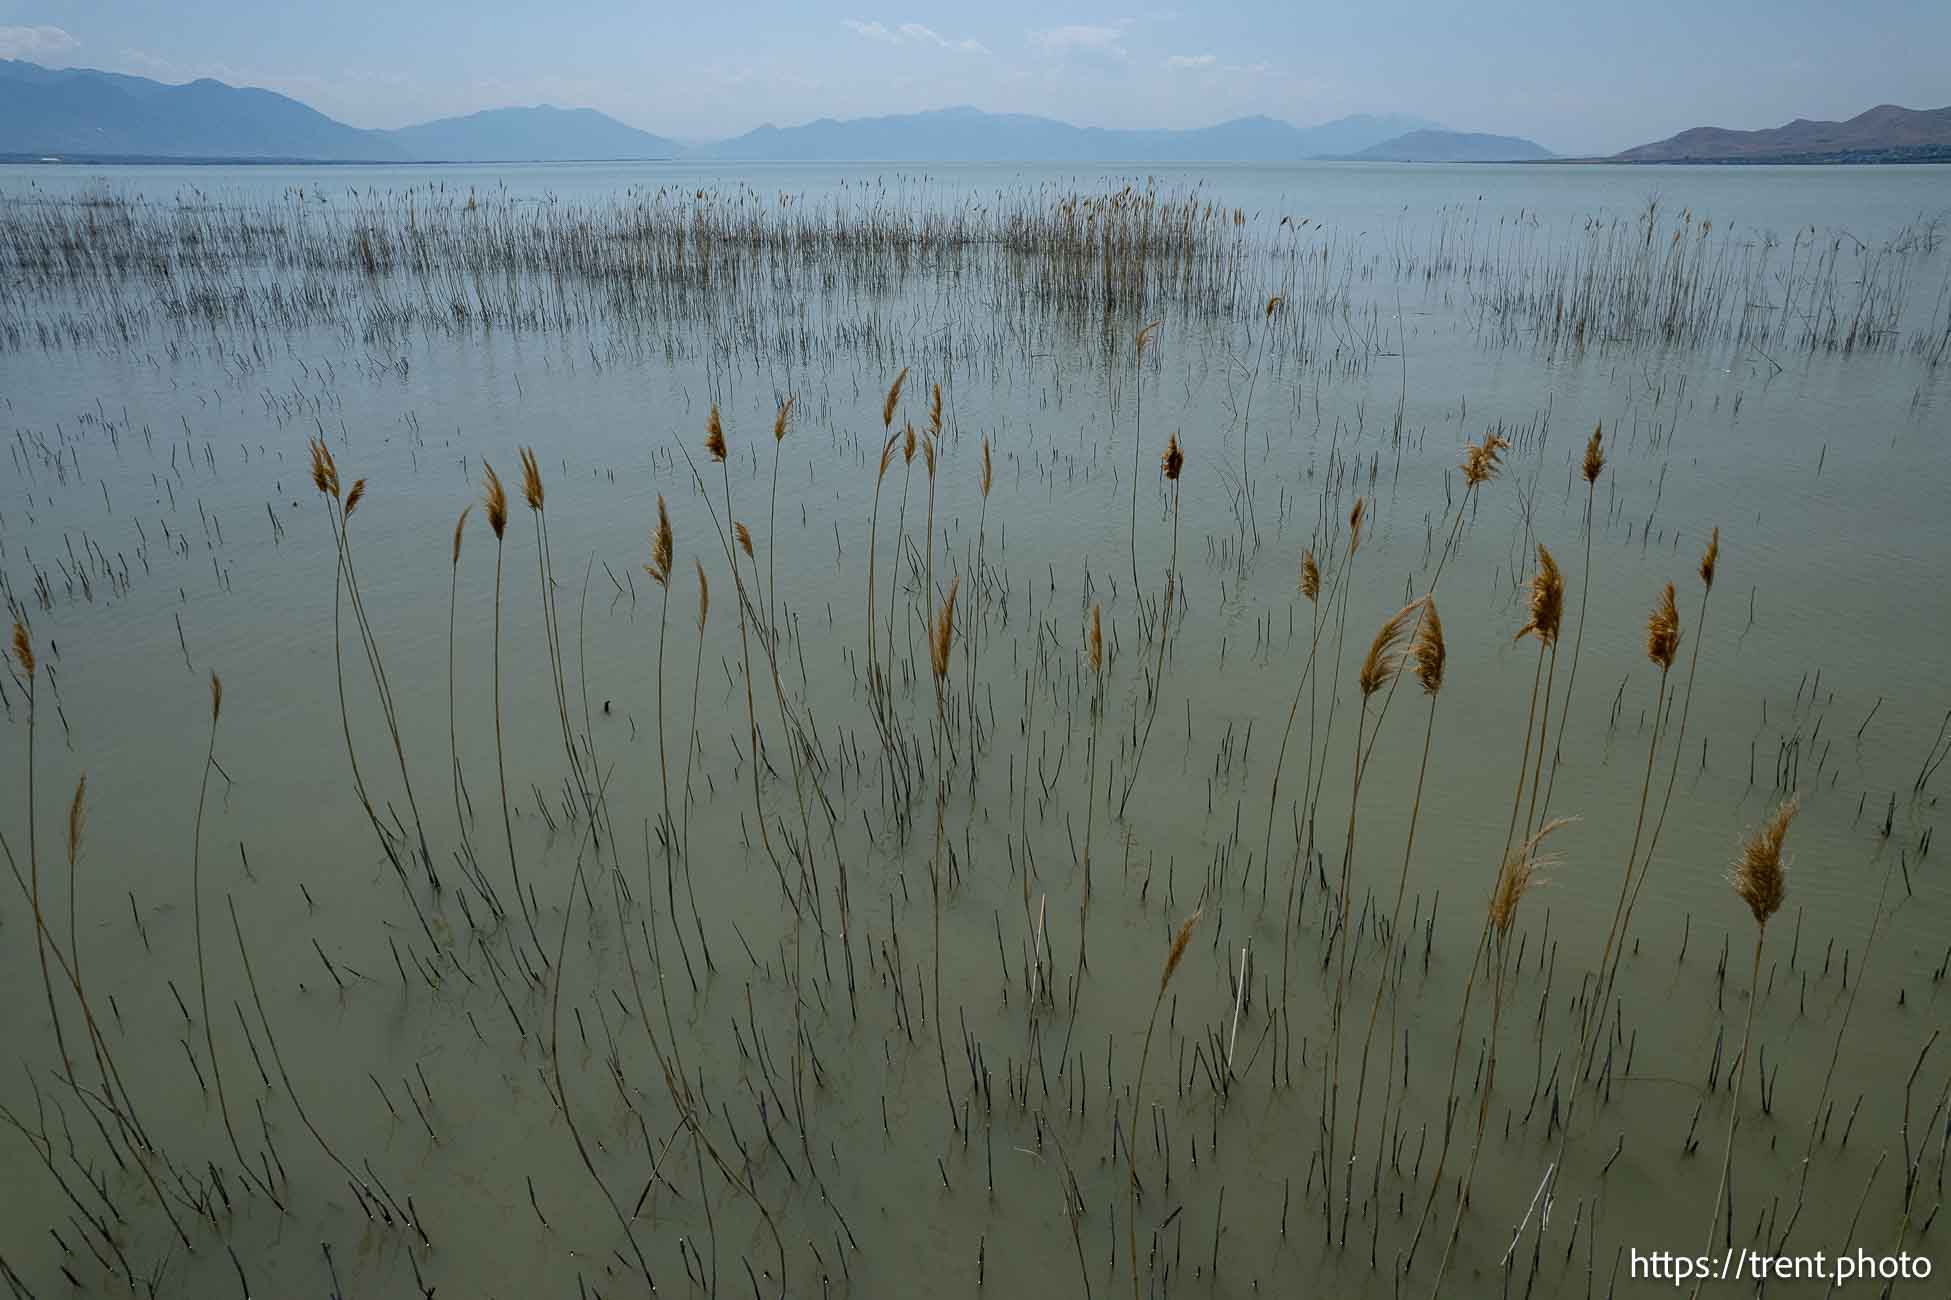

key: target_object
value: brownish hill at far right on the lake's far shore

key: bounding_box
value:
[1612,103,1951,162]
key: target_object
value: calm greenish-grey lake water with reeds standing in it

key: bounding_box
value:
[0,164,1951,1296]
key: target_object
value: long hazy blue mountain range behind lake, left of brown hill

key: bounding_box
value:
[0,59,1551,164]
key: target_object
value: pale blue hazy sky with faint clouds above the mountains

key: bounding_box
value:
[0,0,1951,154]
